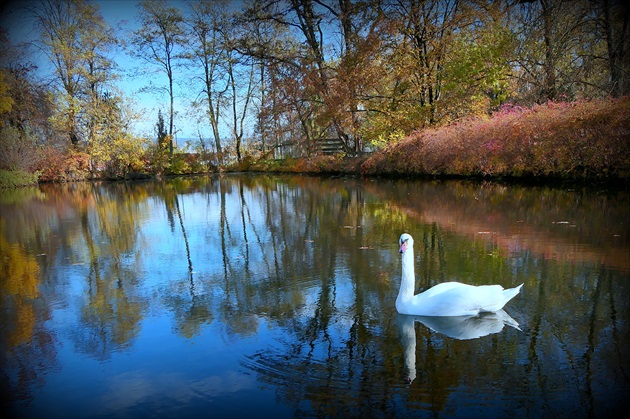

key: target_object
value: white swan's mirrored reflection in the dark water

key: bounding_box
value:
[397,310,521,384]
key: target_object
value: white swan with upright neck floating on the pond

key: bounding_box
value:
[396,233,523,316]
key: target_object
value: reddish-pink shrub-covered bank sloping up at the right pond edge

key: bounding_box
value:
[361,97,630,182]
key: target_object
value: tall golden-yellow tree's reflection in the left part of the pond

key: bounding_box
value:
[71,185,144,359]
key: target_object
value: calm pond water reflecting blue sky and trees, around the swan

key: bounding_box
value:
[0,175,630,418]
